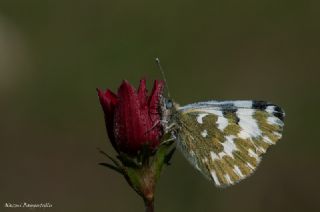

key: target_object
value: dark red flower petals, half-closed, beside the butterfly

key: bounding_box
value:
[98,79,164,155]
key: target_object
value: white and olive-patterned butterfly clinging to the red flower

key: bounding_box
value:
[161,98,285,187]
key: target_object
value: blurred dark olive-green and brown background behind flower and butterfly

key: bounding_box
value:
[0,0,320,212]
